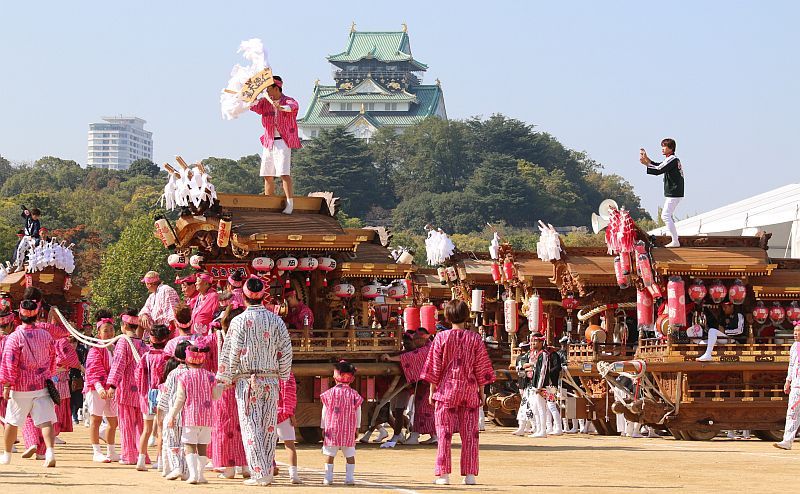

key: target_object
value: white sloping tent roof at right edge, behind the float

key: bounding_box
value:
[650,184,800,258]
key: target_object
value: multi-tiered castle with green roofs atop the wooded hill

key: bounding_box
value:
[297,24,447,139]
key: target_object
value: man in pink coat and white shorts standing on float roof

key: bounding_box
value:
[250,76,301,214]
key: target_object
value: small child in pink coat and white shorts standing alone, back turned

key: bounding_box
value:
[319,360,364,485]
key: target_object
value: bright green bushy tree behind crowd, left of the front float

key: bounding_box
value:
[89,215,175,313]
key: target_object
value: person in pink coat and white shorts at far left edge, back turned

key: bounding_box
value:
[0,300,58,467]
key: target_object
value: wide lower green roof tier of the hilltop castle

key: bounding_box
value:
[297,84,444,127]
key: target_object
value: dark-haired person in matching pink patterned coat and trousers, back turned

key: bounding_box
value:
[421,300,495,485]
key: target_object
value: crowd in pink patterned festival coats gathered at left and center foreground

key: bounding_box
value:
[0,271,494,485]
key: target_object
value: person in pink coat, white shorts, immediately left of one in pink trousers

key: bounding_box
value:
[83,311,119,463]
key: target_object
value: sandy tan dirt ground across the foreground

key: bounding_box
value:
[0,426,800,494]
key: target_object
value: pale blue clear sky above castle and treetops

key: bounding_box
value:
[0,0,800,220]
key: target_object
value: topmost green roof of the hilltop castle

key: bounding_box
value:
[328,31,428,70]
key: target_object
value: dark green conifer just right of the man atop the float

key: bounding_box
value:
[292,127,380,217]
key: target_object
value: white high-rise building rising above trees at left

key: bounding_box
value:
[87,116,153,170]
